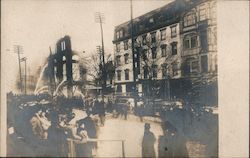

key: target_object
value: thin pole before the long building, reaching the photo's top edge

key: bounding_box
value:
[130,0,138,106]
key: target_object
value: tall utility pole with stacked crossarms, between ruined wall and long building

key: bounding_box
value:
[95,12,106,94]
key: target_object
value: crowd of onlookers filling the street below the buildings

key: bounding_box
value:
[7,92,217,157]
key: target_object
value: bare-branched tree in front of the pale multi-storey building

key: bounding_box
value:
[135,31,181,97]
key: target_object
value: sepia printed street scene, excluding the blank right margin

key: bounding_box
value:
[1,0,248,158]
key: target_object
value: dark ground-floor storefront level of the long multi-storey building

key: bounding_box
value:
[115,77,218,106]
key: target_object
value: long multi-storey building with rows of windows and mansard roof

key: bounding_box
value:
[113,0,217,99]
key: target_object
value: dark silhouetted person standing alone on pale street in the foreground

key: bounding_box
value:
[142,123,156,157]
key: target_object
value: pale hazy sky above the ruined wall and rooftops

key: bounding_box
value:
[1,0,171,91]
